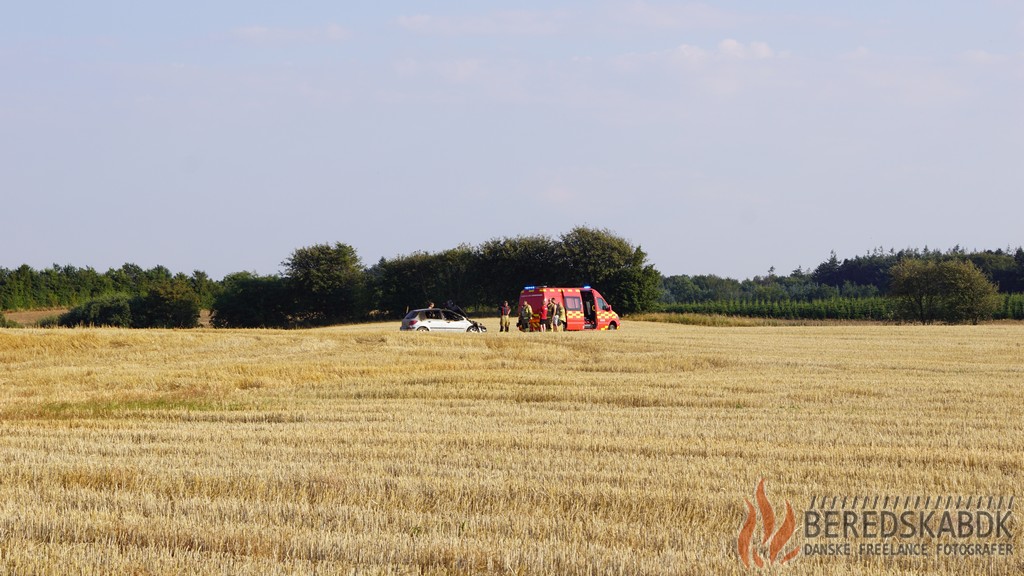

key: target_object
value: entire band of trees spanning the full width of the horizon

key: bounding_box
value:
[0,238,1024,327]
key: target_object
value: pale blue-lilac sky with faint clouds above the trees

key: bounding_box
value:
[0,0,1024,279]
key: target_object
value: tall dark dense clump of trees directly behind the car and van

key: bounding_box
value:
[212,227,662,327]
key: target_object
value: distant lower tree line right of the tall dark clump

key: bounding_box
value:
[660,247,1024,323]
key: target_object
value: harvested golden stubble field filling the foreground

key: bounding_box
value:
[0,322,1024,574]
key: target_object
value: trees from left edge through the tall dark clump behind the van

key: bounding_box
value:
[0,227,662,328]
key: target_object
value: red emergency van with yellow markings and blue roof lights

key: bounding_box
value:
[519,286,622,332]
